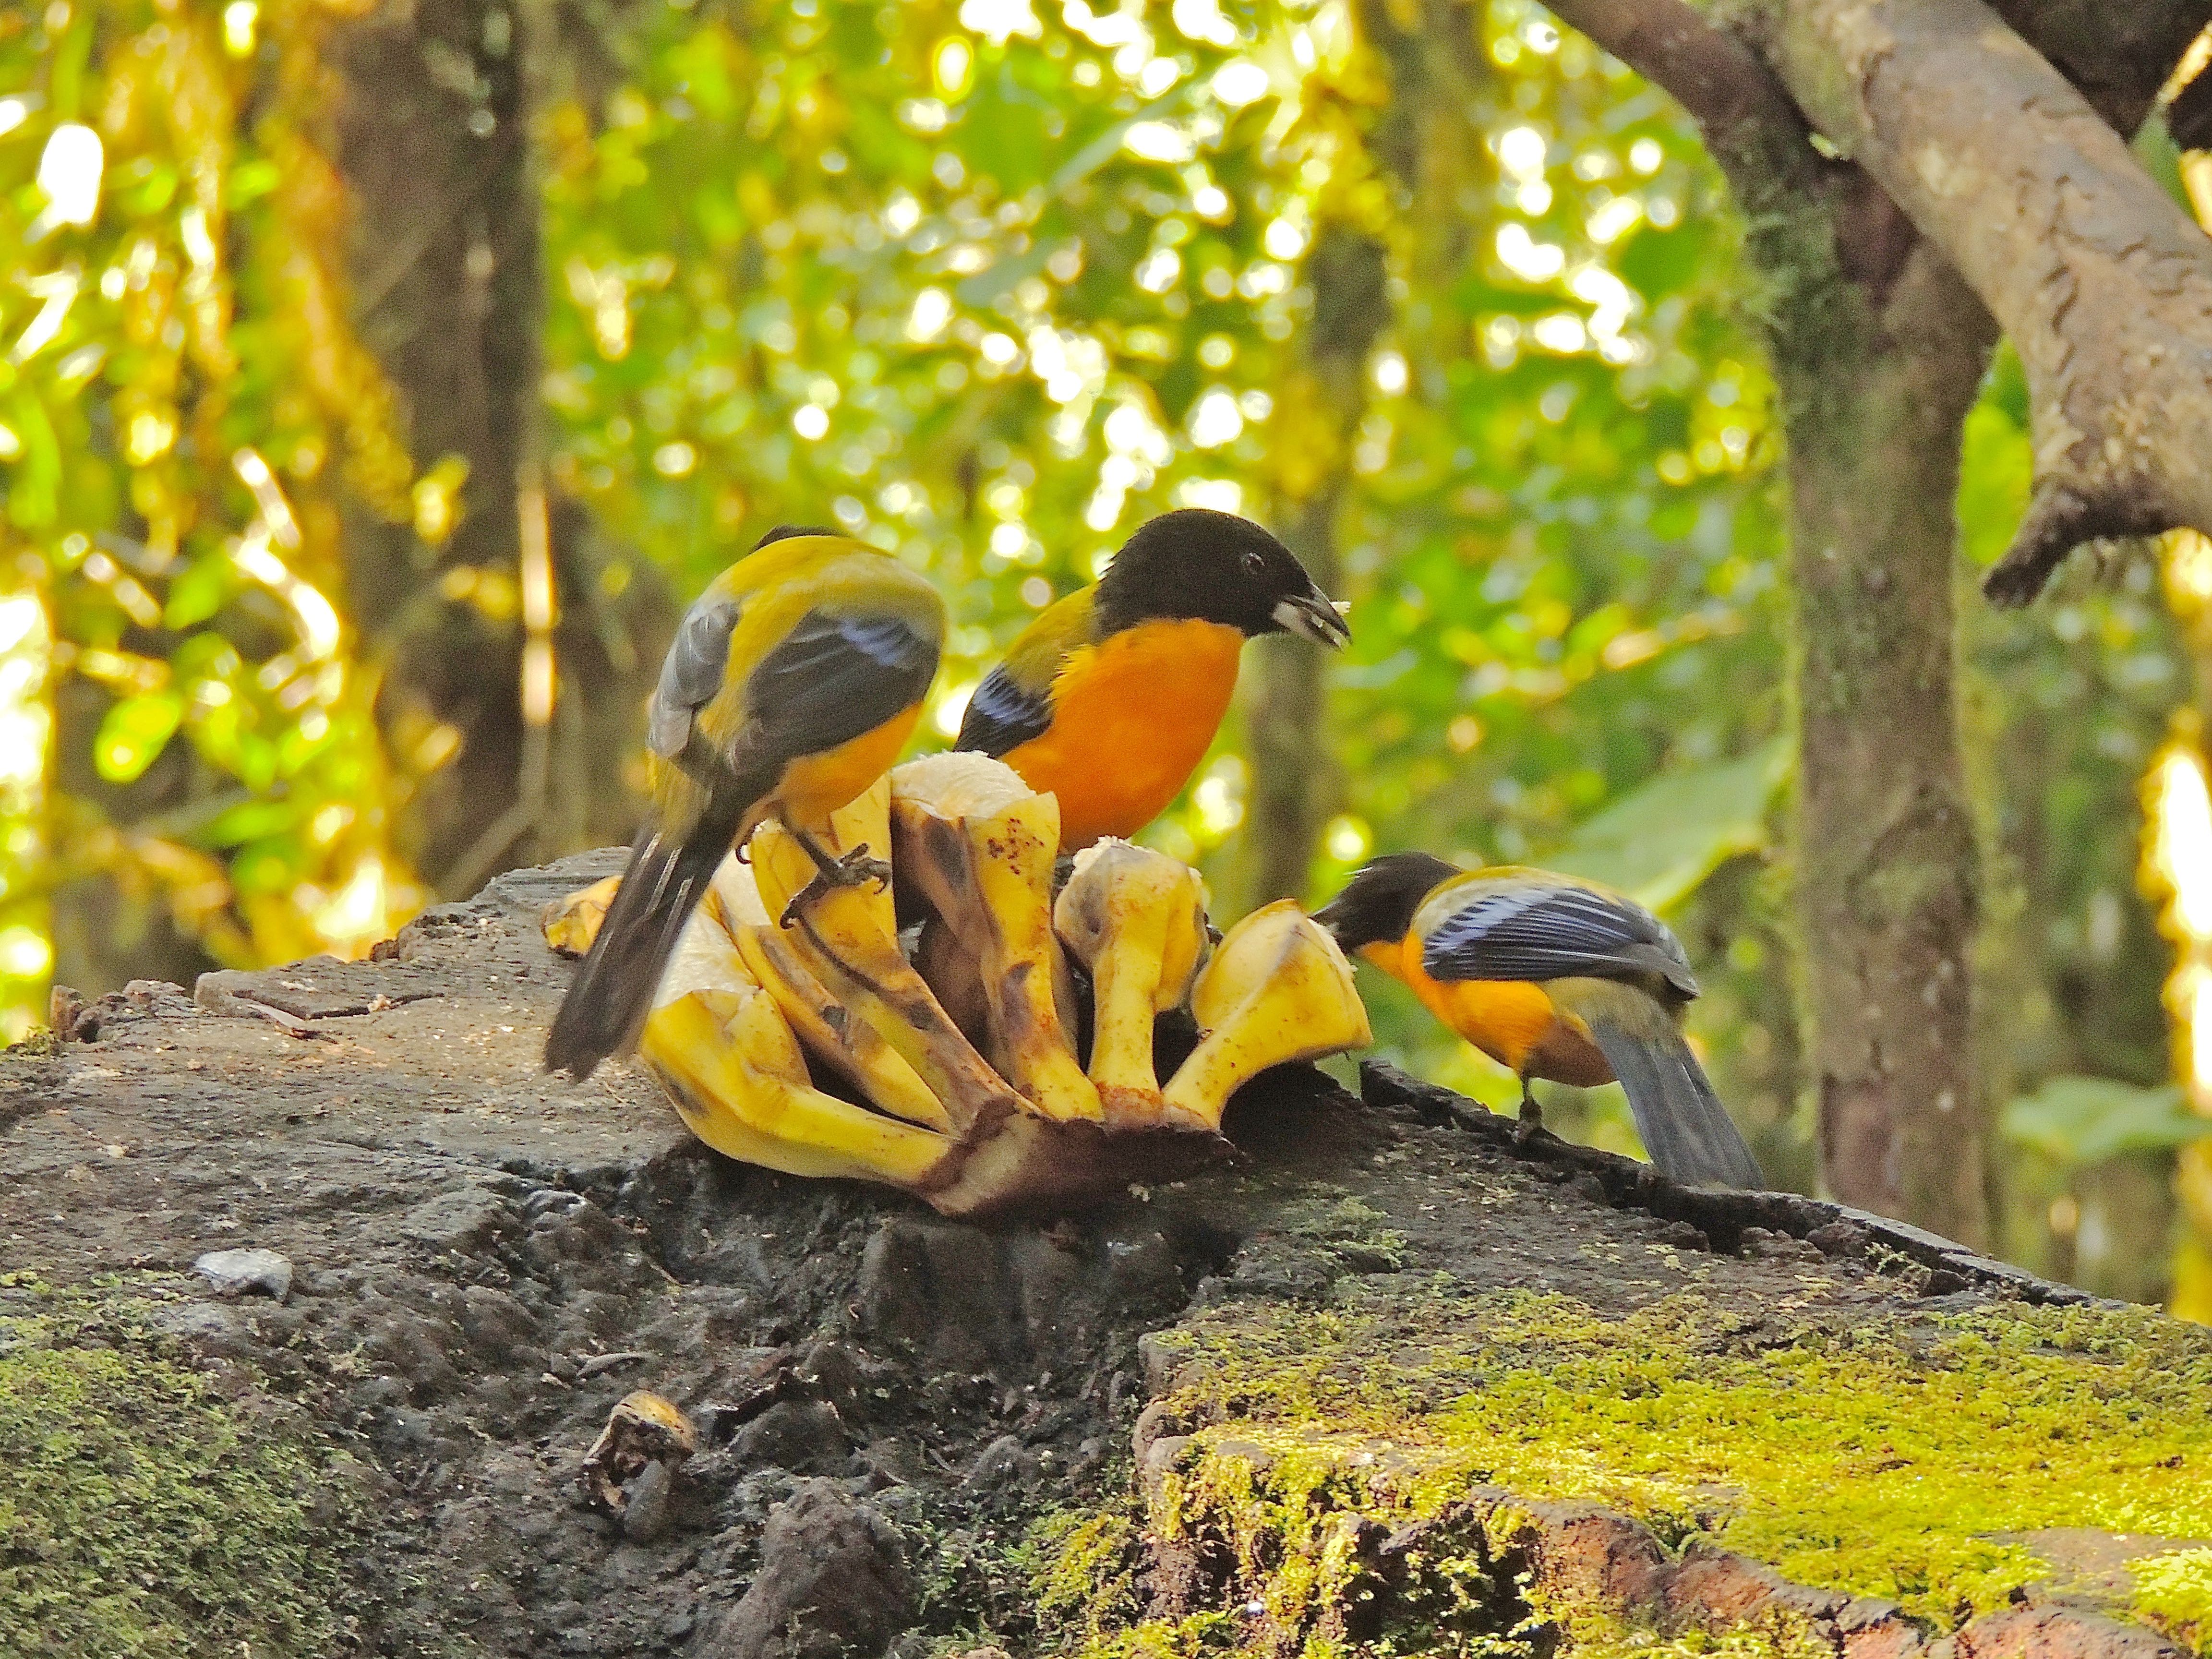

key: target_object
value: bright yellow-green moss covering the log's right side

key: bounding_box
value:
[1048,1281,2212,1655]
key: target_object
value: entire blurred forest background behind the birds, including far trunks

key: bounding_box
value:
[0,0,2212,1318]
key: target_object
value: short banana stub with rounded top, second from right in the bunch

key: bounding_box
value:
[1053,838,1214,1128]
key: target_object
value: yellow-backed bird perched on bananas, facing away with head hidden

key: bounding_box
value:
[546,527,945,1080]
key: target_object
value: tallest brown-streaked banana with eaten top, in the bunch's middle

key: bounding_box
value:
[891,754,1104,1124]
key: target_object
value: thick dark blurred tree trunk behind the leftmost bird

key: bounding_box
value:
[332,0,654,894]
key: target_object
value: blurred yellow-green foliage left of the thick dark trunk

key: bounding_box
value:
[0,0,411,1035]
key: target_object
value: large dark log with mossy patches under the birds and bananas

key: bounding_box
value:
[0,858,2212,1659]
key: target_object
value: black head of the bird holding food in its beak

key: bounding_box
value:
[1097,506,1351,650]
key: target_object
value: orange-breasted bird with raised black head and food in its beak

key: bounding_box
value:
[953,506,1351,852]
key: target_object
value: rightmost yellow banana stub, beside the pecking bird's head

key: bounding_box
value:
[1161,898,1374,1130]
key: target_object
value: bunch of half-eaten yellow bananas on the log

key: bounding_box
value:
[544,752,1371,1214]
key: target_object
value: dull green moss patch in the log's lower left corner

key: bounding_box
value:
[0,1281,358,1659]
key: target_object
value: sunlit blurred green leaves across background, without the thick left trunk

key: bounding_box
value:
[0,0,2188,1309]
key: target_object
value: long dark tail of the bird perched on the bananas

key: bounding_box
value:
[546,801,741,1082]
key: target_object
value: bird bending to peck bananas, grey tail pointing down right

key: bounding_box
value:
[1316,852,1765,1188]
